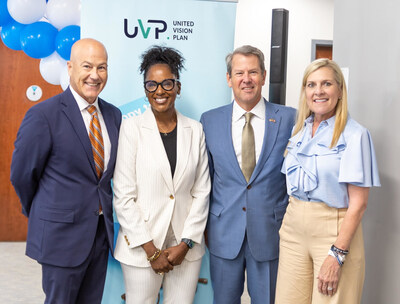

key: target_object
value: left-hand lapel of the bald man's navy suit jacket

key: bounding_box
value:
[61,88,97,178]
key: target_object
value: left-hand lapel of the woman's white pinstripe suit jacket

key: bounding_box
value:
[142,108,174,193]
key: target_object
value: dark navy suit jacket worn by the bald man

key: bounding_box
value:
[11,88,121,267]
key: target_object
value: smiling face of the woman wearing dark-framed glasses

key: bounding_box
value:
[145,64,181,115]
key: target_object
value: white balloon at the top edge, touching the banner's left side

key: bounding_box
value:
[46,0,81,30]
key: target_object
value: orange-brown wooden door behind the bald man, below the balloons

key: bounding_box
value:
[0,41,62,241]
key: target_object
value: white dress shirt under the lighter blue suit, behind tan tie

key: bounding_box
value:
[232,97,265,168]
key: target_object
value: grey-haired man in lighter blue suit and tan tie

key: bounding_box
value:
[201,46,295,304]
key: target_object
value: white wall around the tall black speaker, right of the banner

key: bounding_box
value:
[235,0,334,108]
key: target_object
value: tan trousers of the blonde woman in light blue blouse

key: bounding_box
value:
[275,197,365,304]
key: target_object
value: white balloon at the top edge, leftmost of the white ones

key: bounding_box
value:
[7,0,46,24]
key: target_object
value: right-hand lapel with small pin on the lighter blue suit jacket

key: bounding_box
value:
[249,99,281,182]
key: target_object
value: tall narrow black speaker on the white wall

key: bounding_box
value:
[269,8,289,105]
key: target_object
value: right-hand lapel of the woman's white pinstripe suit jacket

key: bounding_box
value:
[173,111,192,189]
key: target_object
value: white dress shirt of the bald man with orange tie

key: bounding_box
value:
[69,86,111,171]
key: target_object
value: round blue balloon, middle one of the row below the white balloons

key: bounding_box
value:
[20,21,58,59]
